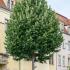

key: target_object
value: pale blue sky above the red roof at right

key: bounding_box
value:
[47,0,70,19]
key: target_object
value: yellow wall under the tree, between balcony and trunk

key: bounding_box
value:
[7,57,31,70]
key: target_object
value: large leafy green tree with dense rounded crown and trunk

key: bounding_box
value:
[6,0,63,70]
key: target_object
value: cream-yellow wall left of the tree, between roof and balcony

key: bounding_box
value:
[0,9,10,53]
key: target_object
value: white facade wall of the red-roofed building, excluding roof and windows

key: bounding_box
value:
[54,34,70,70]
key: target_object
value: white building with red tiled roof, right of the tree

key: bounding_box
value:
[50,14,70,70]
